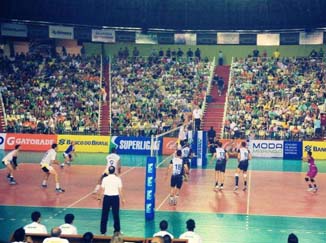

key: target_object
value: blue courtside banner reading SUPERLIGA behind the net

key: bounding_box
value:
[111,136,162,155]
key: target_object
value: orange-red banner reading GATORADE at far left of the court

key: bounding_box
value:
[5,133,57,151]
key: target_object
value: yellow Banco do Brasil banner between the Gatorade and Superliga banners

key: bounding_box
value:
[58,135,110,153]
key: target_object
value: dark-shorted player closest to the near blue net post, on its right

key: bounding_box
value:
[167,150,188,205]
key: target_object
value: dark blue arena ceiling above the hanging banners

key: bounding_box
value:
[0,0,326,30]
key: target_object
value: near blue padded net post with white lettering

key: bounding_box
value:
[145,156,156,221]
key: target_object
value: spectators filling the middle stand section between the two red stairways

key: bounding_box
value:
[111,49,211,136]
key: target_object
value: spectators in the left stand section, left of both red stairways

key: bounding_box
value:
[0,53,101,134]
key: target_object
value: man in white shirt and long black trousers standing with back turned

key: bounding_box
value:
[101,166,125,234]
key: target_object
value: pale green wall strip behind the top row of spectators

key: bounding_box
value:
[84,43,326,64]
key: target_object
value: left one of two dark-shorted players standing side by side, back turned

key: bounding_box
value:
[212,141,229,190]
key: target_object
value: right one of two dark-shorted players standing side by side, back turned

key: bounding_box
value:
[234,141,251,191]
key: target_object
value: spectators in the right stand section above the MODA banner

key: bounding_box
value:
[224,56,326,140]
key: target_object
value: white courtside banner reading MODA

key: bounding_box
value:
[249,140,283,158]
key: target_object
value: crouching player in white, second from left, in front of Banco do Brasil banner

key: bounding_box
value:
[40,143,65,192]
